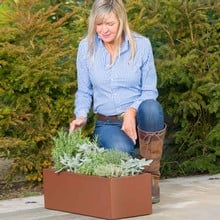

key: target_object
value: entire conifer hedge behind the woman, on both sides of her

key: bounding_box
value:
[0,0,220,181]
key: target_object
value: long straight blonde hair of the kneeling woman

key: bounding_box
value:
[88,0,136,63]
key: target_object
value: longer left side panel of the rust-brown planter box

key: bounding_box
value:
[43,169,111,218]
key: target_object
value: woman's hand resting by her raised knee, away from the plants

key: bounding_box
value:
[121,108,137,144]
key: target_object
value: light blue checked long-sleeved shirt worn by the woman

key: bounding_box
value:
[74,34,158,117]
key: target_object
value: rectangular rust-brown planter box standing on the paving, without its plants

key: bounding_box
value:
[43,169,152,219]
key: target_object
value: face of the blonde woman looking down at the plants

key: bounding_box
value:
[95,12,119,44]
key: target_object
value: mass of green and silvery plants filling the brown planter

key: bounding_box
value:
[52,130,151,177]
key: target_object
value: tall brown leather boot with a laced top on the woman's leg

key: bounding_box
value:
[138,124,167,204]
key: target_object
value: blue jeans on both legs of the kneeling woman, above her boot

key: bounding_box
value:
[94,100,164,156]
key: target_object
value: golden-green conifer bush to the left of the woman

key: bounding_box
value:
[0,0,79,181]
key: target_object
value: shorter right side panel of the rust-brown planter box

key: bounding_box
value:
[111,173,152,218]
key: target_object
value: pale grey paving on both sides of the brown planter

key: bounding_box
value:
[0,174,220,220]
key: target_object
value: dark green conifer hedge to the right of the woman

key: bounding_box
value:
[128,0,220,175]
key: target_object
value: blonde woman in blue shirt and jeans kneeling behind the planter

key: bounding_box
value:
[70,0,165,205]
